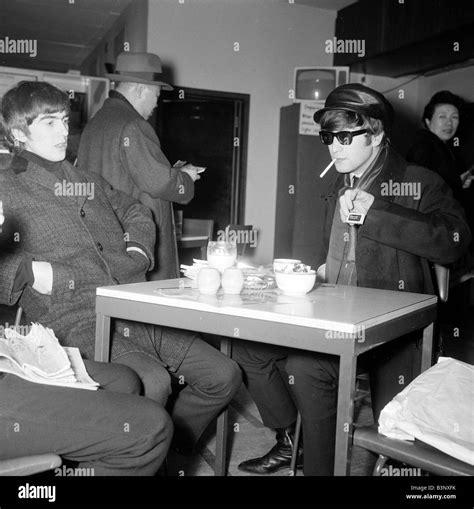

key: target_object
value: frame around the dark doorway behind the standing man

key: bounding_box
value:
[155,85,250,224]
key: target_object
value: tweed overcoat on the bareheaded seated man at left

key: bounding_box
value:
[0,157,192,368]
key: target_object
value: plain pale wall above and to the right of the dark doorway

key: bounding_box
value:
[147,0,336,263]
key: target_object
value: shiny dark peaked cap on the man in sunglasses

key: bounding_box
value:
[314,83,394,128]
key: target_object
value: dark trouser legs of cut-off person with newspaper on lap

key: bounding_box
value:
[0,361,173,476]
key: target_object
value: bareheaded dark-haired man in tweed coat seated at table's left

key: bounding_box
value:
[0,82,241,458]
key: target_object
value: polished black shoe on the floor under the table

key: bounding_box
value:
[238,427,303,475]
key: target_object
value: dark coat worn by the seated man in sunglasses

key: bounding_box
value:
[324,147,471,294]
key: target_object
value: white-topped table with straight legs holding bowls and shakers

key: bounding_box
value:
[95,279,437,475]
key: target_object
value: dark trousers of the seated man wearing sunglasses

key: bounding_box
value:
[233,335,421,476]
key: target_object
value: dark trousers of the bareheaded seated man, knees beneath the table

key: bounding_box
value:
[115,338,242,449]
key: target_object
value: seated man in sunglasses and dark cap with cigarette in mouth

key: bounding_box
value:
[233,84,471,475]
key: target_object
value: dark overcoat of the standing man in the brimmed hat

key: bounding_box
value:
[78,92,194,280]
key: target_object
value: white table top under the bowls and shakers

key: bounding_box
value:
[97,278,437,333]
